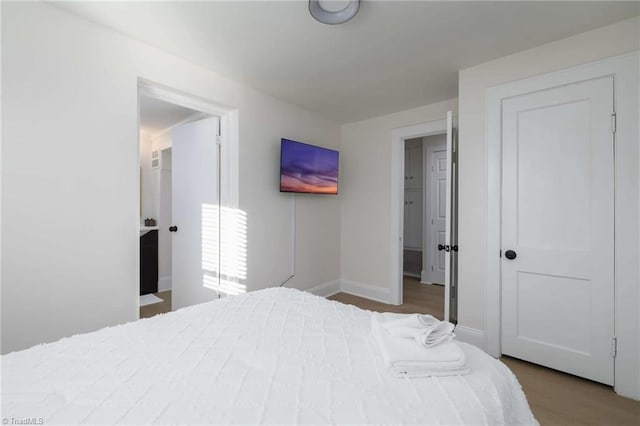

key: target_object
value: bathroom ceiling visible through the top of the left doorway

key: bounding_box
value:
[140,96,204,136]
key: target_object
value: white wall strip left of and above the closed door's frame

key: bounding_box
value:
[458,18,640,330]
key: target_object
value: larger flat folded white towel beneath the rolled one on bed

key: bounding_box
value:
[371,315,470,377]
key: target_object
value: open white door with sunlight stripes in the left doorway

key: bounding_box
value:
[171,117,220,309]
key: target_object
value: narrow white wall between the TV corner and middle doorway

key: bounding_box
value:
[340,99,457,301]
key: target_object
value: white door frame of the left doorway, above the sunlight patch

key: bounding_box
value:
[134,77,240,312]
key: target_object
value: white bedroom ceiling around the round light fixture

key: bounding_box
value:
[55,1,640,123]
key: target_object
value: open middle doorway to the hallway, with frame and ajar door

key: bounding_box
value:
[391,113,458,322]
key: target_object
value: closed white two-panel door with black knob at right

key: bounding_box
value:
[502,77,614,384]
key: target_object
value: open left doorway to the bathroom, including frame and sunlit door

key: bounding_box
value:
[138,80,241,317]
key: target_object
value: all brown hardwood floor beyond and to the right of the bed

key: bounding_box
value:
[329,277,640,426]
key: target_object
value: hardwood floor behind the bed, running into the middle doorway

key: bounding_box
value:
[329,276,444,319]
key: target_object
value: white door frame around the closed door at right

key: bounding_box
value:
[484,51,640,399]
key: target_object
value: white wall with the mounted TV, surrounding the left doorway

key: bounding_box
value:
[2,3,340,353]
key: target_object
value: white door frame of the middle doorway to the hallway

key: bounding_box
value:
[389,119,448,309]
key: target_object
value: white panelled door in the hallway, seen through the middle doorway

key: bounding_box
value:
[428,146,448,284]
